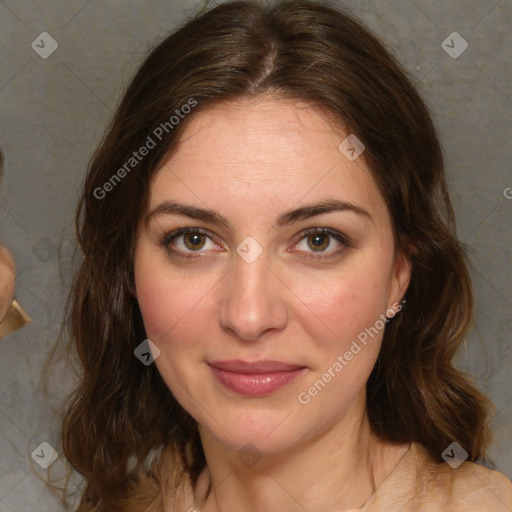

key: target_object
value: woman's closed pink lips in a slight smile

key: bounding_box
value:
[209,360,306,396]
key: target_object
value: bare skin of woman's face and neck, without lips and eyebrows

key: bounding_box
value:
[134,96,410,512]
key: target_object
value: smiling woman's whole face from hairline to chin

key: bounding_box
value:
[134,97,409,452]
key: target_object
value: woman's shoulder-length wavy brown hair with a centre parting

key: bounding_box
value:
[58,1,490,511]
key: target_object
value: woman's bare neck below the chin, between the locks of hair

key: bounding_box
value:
[194,400,407,512]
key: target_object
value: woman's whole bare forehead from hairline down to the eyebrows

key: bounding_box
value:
[150,97,384,223]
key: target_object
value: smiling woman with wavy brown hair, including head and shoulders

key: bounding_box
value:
[63,1,512,512]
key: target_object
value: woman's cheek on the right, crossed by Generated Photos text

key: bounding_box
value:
[297,264,389,410]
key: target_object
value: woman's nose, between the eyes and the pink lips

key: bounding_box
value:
[219,247,288,341]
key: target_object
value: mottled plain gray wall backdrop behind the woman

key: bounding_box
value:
[0,0,512,512]
